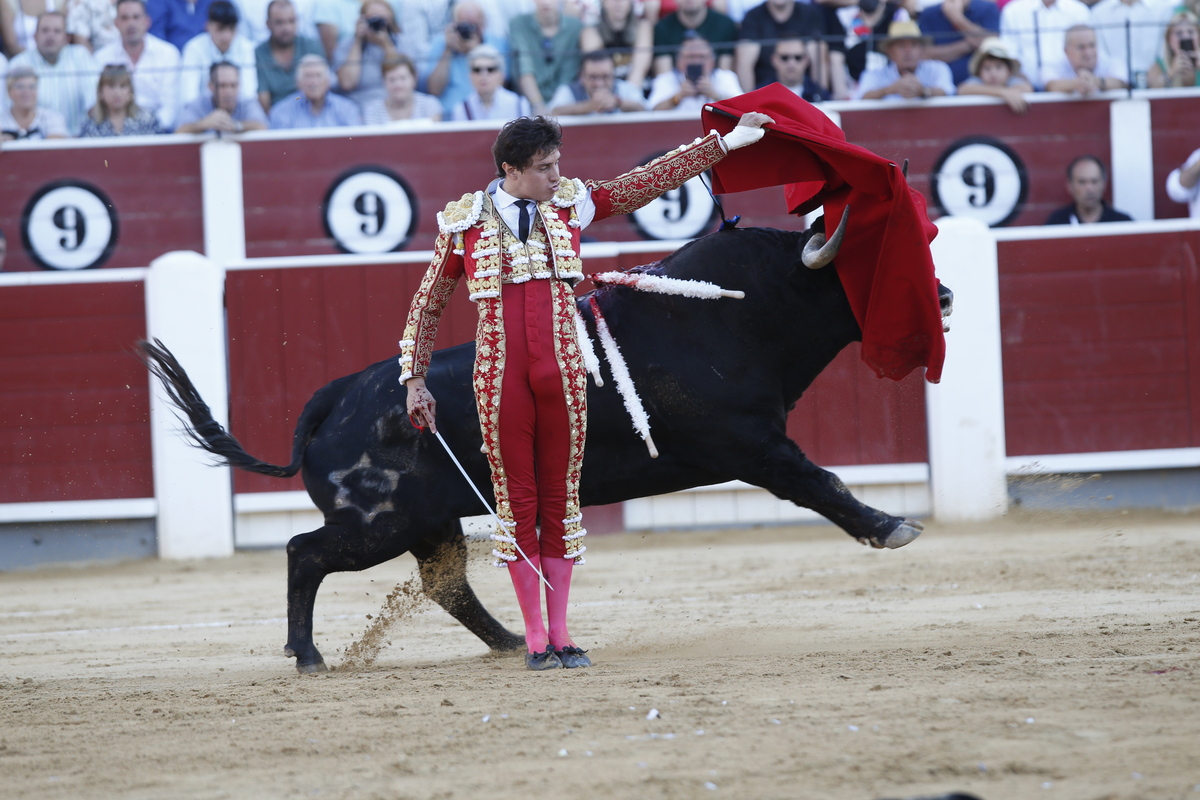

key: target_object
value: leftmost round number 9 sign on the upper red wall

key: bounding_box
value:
[20,180,119,270]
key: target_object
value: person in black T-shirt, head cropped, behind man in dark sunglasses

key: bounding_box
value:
[737,0,830,91]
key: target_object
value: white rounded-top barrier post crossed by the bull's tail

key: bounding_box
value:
[145,252,233,559]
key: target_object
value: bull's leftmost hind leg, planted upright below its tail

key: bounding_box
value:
[283,523,407,673]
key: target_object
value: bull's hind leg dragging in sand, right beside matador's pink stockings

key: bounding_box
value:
[412,521,524,650]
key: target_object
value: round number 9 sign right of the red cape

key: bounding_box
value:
[930,136,1030,228]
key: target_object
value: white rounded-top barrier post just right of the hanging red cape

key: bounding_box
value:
[925,217,1008,522]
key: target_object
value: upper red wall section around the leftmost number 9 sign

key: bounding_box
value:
[0,142,204,272]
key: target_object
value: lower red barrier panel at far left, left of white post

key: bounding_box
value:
[0,282,154,503]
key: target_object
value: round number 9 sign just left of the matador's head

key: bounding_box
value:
[320,164,418,253]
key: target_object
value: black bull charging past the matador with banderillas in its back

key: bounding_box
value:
[142,228,945,672]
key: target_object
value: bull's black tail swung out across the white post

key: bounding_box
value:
[137,339,329,477]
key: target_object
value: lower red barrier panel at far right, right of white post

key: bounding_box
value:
[1000,231,1200,456]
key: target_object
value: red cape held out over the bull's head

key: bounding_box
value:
[703,83,946,384]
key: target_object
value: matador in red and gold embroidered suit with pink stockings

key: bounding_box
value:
[400,113,772,670]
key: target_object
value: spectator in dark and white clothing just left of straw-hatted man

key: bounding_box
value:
[822,0,911,100]
